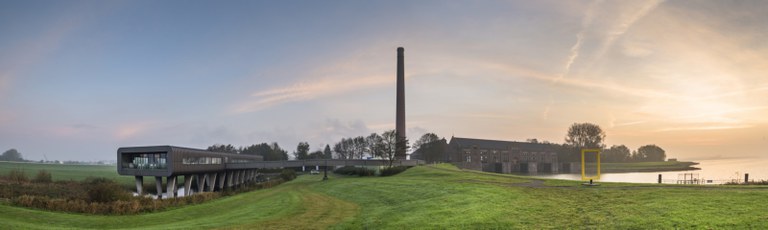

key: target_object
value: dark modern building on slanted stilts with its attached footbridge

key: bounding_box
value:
[117,146,424,198]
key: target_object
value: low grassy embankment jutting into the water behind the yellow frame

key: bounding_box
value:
[600,161,699,173]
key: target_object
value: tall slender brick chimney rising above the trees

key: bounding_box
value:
[395,47,406,160]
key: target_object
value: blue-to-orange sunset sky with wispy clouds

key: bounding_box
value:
[0,0,768,161]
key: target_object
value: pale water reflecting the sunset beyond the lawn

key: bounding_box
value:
[536,158,768,184]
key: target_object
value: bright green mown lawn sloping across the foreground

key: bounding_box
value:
[0,165,768,229]
